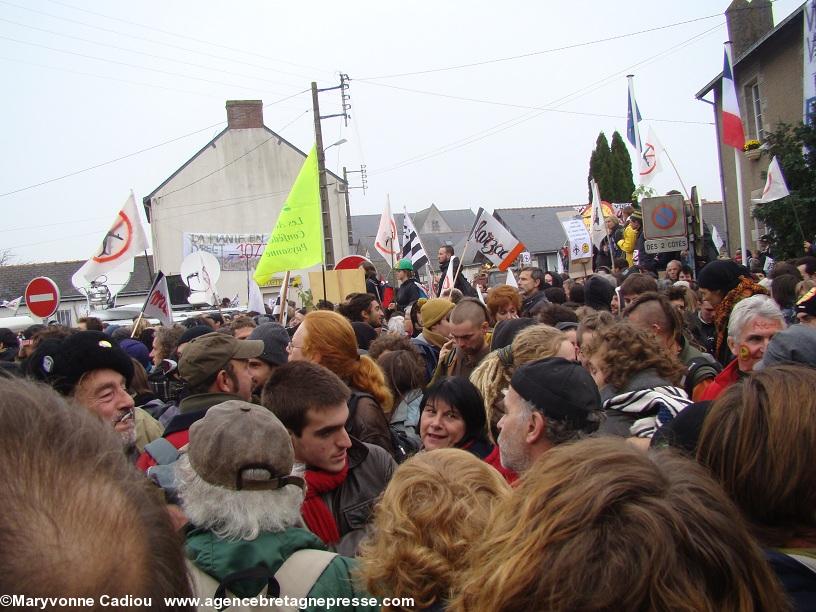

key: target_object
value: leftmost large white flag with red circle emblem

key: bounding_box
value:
[74,193,147,282]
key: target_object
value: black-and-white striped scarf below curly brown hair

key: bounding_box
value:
[603,385,693,438]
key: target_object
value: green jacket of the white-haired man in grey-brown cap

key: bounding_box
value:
[185,527,378,611]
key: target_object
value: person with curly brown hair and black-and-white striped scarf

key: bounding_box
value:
[581,321,692,438]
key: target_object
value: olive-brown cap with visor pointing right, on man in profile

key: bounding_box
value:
[179,332,264,387]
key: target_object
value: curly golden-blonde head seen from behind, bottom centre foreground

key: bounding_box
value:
[359,448,510,610]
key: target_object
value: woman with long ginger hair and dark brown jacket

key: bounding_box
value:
[289,310,394,456]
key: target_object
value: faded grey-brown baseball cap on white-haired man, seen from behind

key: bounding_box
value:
[187,400,304,491]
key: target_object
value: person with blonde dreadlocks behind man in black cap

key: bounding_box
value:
[470,325,575,440]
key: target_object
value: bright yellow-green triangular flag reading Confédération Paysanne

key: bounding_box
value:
[254,147,323,286]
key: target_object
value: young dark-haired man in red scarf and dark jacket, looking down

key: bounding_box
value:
[261,361,396,556]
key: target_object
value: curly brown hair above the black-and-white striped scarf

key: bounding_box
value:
[581,321,686,390]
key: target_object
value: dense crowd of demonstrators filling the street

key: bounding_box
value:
[0,238,816,611]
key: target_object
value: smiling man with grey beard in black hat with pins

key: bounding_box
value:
[28,331,162,460]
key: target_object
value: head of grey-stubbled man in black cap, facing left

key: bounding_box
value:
[498,357,601,474]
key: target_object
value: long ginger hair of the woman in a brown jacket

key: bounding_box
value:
[301,310,394,413]
